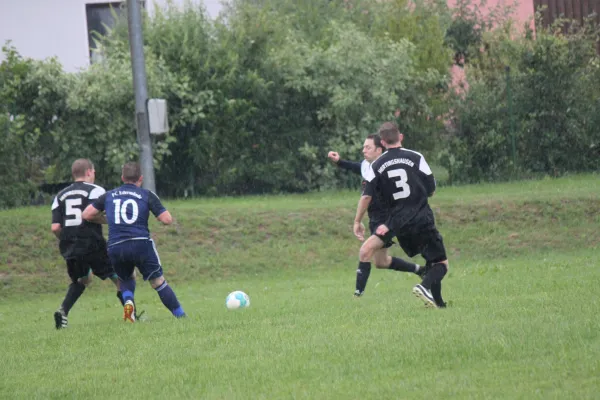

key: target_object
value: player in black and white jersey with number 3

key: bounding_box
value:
[354,122,448,307]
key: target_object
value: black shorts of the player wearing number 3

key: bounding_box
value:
[377,219,447,264]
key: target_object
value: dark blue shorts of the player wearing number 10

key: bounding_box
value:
[108,239,163,281]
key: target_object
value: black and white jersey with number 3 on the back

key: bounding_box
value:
[365,148,435,229]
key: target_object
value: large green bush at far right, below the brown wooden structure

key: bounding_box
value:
[440,12,600,182]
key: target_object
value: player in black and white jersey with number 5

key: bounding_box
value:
[52,158,125,329]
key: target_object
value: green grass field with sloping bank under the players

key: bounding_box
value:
[0,175,600,399]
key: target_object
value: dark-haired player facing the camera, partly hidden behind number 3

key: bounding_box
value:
[327,134,425,297]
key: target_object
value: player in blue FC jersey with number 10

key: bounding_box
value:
[83,162,185,322]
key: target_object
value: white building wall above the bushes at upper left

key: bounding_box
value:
[0,0,222,72]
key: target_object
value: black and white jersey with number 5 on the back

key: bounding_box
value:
[52,182,106,258]
